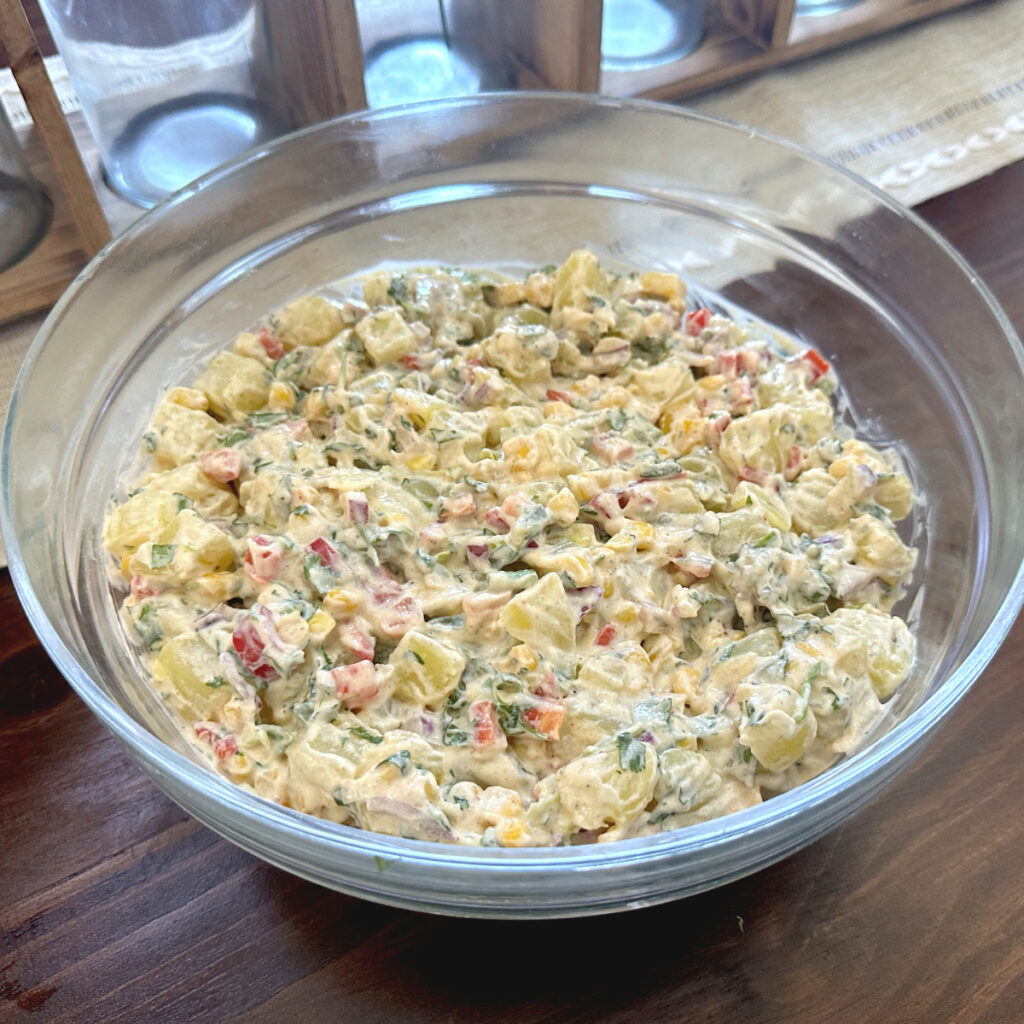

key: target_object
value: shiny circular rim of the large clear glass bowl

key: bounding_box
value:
[0,91,1024,897]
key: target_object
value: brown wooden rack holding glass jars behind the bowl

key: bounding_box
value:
[0,0,978,323]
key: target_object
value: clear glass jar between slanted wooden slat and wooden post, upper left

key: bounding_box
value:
[40,0,279,207]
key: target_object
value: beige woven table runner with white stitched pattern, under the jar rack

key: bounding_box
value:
[0,0,1024,565]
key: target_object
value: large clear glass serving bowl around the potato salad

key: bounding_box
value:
[2,93,1024,918]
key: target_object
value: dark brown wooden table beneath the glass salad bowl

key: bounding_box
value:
[0,163,1024,1024]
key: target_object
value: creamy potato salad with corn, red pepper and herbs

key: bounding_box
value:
[103,251,914,847]
